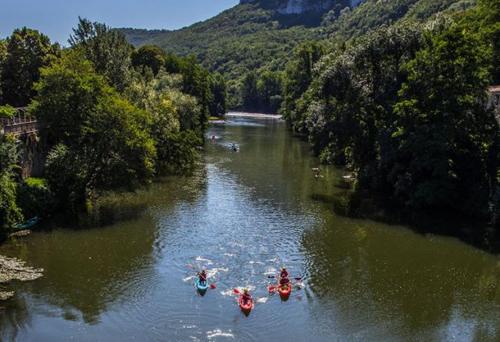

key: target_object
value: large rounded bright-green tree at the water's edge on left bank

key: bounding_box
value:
[31,51,156,210]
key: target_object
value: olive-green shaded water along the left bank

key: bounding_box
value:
[0,168,206,330]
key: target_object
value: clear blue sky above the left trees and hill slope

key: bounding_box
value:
[0,0,239,44]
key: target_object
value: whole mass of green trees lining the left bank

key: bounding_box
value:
[0,19,226,235]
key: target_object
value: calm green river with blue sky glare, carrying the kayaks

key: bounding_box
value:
[0,118,500,342]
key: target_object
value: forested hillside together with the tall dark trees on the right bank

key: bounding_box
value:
[122,0,500,227]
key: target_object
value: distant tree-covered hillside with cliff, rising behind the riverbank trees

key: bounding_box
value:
[121,0,475,107]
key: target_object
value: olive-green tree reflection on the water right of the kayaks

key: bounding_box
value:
[303,219,500,339]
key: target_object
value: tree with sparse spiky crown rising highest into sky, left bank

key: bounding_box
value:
[69,17,133,91]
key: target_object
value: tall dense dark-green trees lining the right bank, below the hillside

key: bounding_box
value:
[283,0,500,224]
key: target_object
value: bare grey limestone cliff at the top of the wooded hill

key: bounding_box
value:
[240,0,364,14]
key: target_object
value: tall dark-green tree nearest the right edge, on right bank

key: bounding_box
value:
[391,25,499,215]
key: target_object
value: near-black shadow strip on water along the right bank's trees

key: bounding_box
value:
[311,181,500,254]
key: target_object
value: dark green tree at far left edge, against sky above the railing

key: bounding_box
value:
[0,27,58,107]
